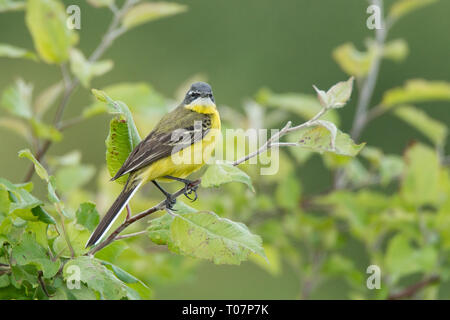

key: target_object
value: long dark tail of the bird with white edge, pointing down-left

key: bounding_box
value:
[86,176,142,248]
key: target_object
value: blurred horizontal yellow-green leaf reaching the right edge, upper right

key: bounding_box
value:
[381,79,450,108]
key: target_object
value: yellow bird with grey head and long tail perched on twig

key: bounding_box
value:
[86,82,221,248]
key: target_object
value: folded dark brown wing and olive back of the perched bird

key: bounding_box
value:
[111,106,211,180]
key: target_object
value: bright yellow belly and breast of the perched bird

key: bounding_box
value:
[139,111,220,182]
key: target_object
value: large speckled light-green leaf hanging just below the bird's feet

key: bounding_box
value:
[170,212,266,264]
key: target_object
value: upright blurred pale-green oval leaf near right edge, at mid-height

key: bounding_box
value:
[400,143,439,207]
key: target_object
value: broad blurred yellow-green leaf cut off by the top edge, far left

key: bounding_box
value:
[25,0,77,64]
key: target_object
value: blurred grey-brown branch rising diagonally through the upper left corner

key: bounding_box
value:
[23,0,140,182]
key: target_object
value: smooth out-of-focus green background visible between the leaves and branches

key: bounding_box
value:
[0,0,450,299]
